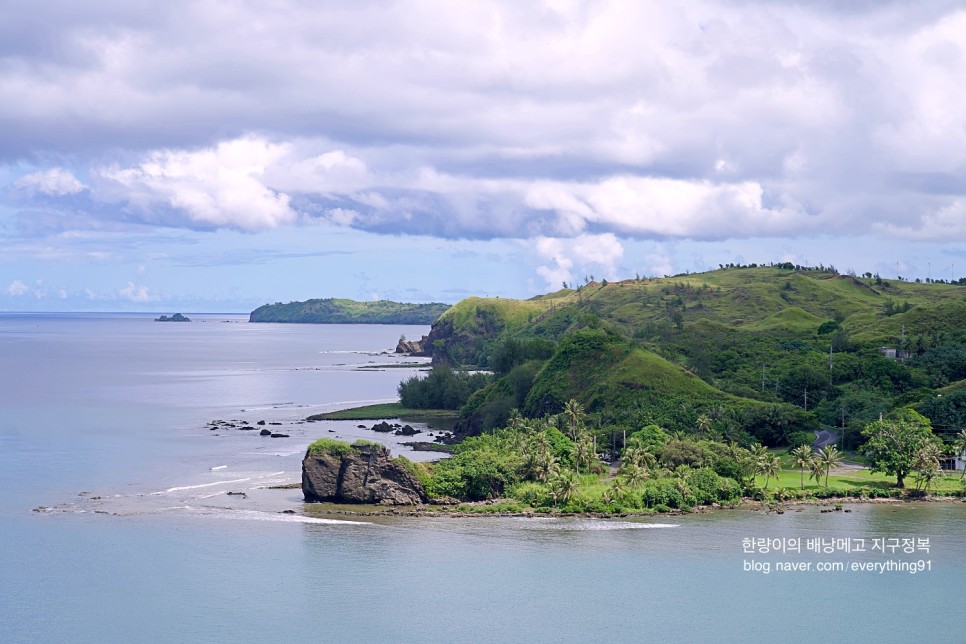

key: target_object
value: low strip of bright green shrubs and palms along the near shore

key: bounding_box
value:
[410,400,966,514]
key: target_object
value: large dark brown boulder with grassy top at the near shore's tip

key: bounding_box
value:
[302,444,426,505]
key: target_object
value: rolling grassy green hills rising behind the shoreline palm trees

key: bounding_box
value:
[412,265,966,443]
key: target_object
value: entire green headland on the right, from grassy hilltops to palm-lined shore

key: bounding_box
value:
[294,262,966,515]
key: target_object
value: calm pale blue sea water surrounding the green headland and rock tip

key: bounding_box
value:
[0,315,966,642]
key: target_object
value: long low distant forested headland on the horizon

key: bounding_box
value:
[248,298,449,324]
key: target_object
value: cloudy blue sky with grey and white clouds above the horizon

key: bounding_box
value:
[0,0,966,312]
